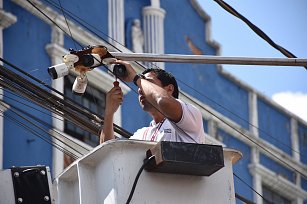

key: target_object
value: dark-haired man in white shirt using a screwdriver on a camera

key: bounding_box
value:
[100,60,205,143]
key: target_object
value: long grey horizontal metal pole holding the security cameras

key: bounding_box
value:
[110,52,307,66]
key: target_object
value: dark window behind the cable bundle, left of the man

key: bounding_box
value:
[64,75,106,147]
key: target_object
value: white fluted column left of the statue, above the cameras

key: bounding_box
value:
[108,0,125,48]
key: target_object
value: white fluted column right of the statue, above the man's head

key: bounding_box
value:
[143,0,165,69]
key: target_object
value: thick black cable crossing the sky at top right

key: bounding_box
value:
[214,0,307,70]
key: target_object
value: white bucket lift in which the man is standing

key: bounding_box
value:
[53,140,242,204]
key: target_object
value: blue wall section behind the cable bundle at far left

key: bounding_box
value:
[3,1,52,168]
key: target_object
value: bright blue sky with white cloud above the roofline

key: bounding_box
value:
[198,0,307,122]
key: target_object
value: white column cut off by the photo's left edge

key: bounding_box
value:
[0,3,17,169]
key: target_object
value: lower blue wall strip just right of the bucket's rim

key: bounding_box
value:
[217,129,253,200]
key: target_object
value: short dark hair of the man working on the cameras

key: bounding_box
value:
[142,68,179,98]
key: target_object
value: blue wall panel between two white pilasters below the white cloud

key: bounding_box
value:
[257,98,292,155]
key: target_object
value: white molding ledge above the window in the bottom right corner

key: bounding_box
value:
[249,164,307,200]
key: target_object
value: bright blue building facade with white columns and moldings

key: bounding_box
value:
[0,0,307,204]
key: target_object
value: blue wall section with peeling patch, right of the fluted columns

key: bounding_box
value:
[161,0,248,128]
